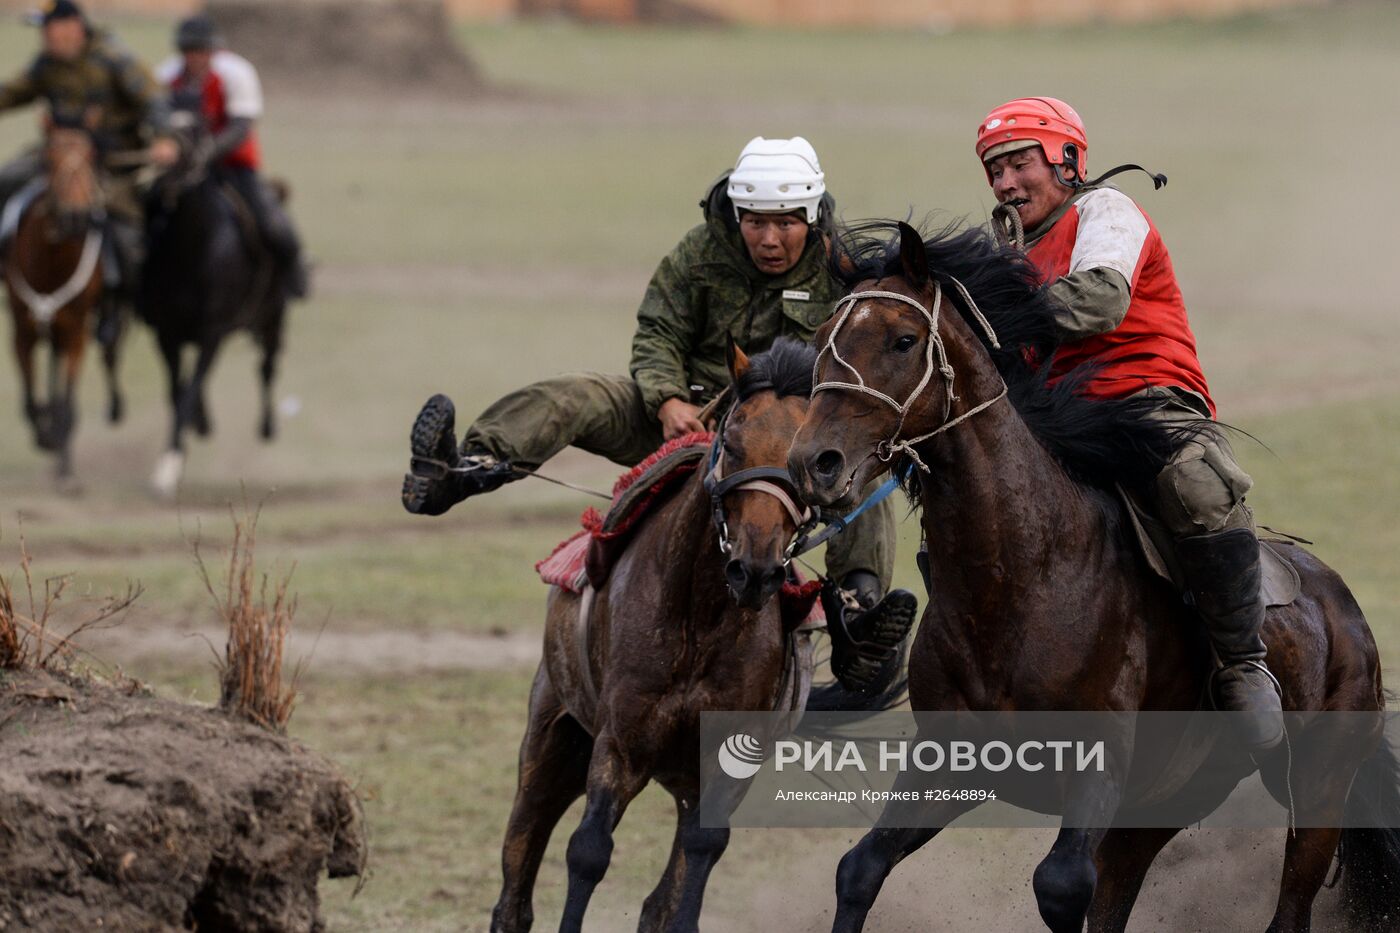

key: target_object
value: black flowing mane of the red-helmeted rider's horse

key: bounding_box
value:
[830,221,1198,490]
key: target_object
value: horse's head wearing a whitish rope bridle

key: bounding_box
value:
[788,223,1005,509]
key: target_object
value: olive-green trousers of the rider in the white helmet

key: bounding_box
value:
[462,373,895,590]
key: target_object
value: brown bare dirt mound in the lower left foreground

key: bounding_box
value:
[0,671,365,930]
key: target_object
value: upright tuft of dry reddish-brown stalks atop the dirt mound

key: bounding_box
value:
[193,506,301,733]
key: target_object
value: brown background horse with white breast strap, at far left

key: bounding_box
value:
[4,126,122,478]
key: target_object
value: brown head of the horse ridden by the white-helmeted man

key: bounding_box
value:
[706,340,813,609]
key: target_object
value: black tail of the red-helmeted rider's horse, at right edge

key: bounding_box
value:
[1337,737,1400,930]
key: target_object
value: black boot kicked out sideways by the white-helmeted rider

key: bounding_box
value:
[402,395,521,516]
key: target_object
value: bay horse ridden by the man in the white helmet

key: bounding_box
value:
[491,340,902,933]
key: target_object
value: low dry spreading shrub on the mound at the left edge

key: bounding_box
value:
[0,535,141,671]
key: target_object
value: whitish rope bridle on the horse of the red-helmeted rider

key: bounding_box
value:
[812,276,1007,479]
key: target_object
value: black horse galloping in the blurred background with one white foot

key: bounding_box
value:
[139,111,287,497]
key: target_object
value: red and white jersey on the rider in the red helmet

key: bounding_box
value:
[1026,188,1215,415]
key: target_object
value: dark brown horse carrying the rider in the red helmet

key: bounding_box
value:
[788,224,1400,933]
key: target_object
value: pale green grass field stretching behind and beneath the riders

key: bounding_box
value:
[0,3,1400,930]
